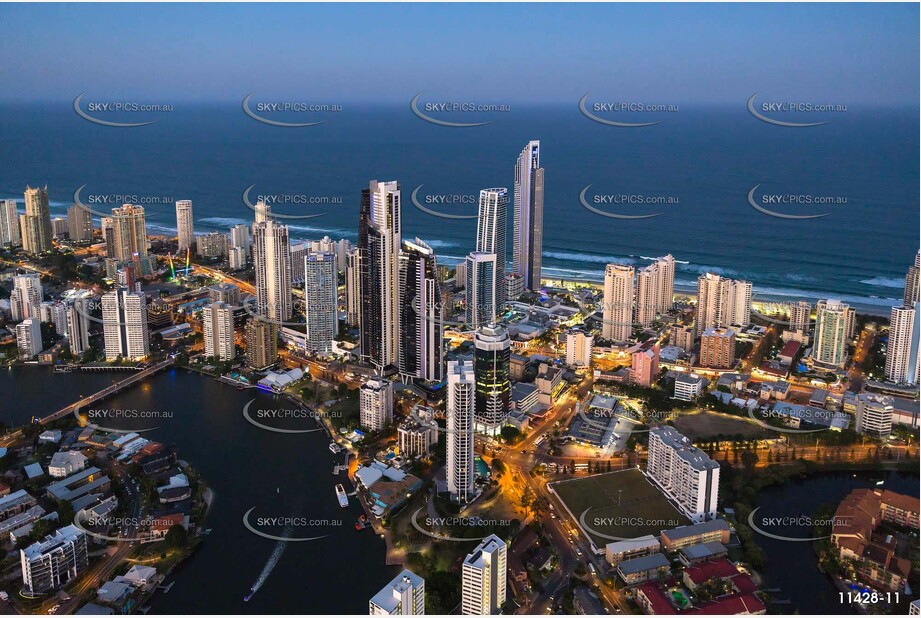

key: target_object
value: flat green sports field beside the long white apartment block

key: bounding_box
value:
[551,469,690,549]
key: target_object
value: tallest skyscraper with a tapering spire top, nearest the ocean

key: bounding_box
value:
[513,140,544,291]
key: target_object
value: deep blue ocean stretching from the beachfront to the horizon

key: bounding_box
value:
[0,101,919,308]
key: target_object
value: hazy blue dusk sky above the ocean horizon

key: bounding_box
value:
[0,3,919,105]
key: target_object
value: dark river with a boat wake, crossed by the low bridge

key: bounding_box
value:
[0,367,397,614]
